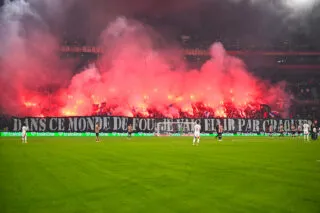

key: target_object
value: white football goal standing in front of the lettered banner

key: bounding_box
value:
[155,122,195,136]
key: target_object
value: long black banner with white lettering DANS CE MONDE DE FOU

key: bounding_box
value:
[2,116,311,133]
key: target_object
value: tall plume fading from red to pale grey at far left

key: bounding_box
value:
[0,0,71,115]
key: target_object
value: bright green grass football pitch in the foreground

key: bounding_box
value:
[0,137,320,213]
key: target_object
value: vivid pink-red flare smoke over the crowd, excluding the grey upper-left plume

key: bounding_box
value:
[0,15,286,118]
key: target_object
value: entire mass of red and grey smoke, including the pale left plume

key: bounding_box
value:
[0,0,292,117]
